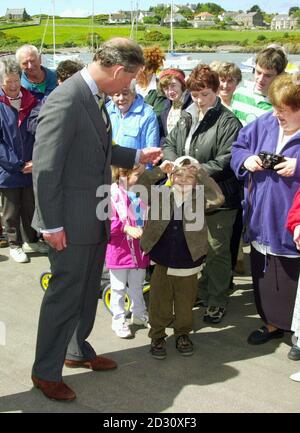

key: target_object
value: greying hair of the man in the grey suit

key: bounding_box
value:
[93,38,145,72]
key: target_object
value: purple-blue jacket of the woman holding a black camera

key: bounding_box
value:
[231,109,300,256]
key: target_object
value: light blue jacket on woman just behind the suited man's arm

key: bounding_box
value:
[106,95,159,149]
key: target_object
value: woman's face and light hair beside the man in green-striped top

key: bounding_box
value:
[210,61,242,109]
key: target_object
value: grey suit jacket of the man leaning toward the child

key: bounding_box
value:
[33,73,136,244]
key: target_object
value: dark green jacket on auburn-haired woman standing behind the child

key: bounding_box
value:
[162,97,242,209]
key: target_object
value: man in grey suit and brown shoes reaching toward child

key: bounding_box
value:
[32,38,161,400]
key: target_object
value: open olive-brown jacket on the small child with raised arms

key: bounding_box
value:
[139,167,224,261]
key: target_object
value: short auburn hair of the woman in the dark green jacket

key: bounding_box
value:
[186,64,220,93]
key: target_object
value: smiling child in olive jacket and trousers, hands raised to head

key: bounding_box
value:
[140,156,224,359]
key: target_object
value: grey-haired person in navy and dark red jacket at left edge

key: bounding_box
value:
[0,60,47,263]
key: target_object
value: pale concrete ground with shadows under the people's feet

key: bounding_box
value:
[0,245,300,414]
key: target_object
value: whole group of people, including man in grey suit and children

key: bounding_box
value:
[0,38,300,400]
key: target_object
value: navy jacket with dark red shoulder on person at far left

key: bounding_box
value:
[0,88,37,188]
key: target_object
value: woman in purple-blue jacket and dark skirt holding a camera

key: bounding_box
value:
[231,71,300,344]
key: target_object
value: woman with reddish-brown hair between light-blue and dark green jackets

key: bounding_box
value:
[158,68,192,145]
